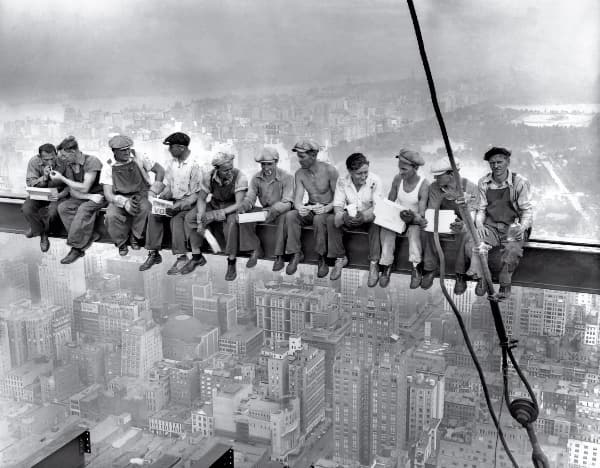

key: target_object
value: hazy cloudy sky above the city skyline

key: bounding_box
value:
[0,0,600,102]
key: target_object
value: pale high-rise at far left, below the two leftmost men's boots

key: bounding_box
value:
[38,242,85,316]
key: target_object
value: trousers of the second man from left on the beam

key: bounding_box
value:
[58,197,106,249]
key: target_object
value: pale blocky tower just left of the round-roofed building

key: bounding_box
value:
[121,320,163,377]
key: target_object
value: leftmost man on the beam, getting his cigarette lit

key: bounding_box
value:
[21,143,68,252]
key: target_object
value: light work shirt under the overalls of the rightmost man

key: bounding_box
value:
[477,169,533,229]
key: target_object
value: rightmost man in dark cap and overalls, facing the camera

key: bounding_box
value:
[465,147,533,299]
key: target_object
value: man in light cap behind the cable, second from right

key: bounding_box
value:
[421,157,479,295]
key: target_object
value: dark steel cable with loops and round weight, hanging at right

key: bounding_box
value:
[407,0,550,468]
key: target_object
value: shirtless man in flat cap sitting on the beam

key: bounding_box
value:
[286,140,338,278]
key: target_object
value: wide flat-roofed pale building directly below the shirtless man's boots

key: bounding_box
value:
[255,281,339,346]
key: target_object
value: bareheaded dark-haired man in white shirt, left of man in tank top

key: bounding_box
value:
[327,153,383,288]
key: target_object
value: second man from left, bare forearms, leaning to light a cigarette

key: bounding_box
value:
[50,136,106,264]
